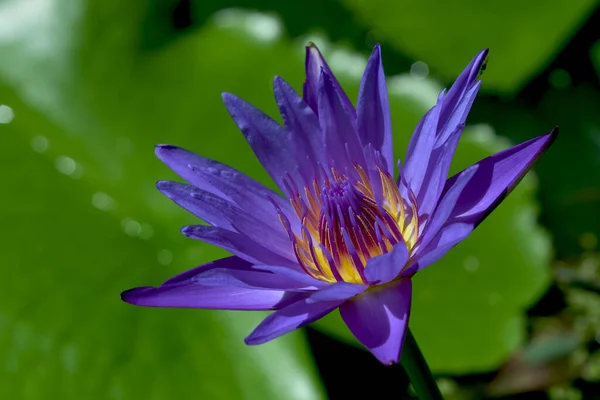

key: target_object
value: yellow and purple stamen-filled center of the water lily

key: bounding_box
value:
[280,166,419,283]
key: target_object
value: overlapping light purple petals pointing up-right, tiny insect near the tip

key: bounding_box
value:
[404,50,487,220]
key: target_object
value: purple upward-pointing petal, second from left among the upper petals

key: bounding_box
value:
[274,77,327,184]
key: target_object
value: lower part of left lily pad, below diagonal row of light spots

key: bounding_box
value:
[0,127,320,399]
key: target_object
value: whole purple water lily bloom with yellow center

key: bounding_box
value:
[122,44,557,364]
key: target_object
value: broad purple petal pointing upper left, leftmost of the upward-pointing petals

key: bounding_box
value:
[223,93,297,191]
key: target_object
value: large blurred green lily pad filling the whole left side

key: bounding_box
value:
[0,0,323,399]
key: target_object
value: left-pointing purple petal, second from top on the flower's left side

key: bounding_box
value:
[157,181,296,260]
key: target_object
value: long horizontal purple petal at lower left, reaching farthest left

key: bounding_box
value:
[121,257,306,310]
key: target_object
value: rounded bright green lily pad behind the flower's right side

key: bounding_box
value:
[316,77,552,374]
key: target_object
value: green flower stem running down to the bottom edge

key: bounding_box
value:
[400,329,444,400]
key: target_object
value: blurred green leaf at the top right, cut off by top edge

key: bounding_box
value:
[343,0,597,93]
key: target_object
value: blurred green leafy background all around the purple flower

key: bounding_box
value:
[0,0,600,400]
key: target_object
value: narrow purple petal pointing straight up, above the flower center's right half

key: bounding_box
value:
[356,45,394,172]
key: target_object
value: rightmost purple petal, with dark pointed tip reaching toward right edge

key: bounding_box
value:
[406,128,558,274]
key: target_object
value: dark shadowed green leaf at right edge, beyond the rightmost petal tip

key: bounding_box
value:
[538,86,600,257]
